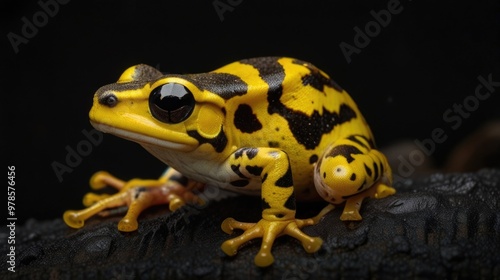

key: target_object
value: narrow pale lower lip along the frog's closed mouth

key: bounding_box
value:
[90,120,192,151]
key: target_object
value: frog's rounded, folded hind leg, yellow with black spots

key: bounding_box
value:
[314,135,396,221]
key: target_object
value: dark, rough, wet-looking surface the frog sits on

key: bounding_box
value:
[0,169,500,279]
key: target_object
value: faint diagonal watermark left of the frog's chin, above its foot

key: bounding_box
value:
[51,129,103,183]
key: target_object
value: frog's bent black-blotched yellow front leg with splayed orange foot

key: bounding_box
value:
[221,148,333,267]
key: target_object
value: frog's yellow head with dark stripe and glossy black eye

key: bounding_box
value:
[89,64,225,151]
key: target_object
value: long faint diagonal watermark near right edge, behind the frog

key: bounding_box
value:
[394,73,500,182]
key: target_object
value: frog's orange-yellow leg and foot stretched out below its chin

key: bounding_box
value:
[63,168,204,232]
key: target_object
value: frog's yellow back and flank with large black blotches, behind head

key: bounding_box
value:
[199,57,373,196]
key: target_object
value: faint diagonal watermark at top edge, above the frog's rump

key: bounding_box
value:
[339,0,411,63]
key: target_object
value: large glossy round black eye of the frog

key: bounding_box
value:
[149,83,195,123]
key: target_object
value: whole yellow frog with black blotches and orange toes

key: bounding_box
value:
[63,56,396,267]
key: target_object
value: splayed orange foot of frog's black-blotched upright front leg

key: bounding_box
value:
[221,205,333,267]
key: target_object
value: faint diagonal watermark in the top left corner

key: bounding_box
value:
[7,0,70,54]
